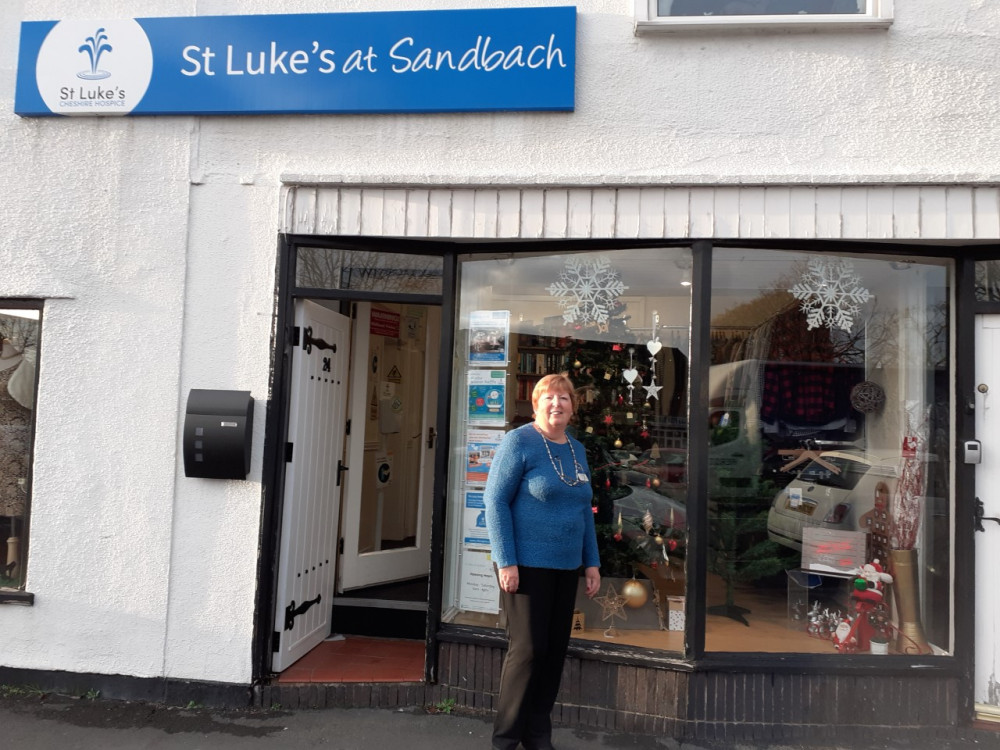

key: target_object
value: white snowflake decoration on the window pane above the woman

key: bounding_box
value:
[547,255,628,327]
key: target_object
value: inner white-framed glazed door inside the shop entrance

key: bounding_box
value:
[337,302,441,593]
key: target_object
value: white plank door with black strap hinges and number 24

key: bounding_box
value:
[271,301,351,672]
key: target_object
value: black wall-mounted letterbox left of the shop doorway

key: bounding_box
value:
[184,388,253,479]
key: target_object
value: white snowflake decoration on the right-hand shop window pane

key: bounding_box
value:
[788,258,871,332]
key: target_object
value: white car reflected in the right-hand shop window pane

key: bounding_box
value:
[767,451,899,550]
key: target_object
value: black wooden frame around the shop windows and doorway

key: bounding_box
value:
[254,235,976,700]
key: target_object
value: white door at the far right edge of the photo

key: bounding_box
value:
[976,315,1000,720]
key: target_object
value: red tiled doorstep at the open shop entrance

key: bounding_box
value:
[278,636,424,683]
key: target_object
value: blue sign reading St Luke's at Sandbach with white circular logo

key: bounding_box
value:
[14,6,576,117]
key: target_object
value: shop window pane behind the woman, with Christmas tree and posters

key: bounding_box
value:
[443,248,691,651]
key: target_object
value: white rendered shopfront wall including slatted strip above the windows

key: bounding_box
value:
[0,0,1000,683]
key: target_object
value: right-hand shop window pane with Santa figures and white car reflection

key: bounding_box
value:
[705,248,953,655]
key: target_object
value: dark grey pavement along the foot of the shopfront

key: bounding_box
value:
[0,693,1000,750]
